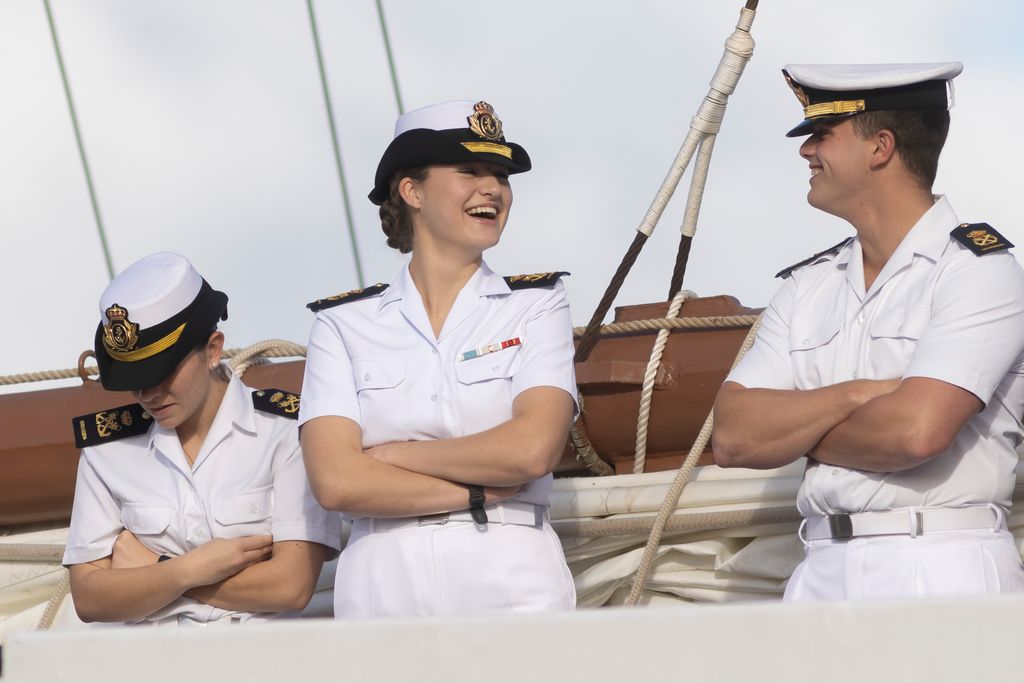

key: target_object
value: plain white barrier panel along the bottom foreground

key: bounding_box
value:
[3,596,1024,683]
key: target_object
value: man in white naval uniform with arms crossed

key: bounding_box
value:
[714,62,1024,600]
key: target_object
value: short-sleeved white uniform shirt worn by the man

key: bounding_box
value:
[728,197,1024,515]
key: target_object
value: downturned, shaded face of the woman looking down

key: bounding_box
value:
[131,332,224,429]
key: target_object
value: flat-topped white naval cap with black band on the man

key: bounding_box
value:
[782,61,964,137]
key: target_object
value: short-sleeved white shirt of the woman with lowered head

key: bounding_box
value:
[63,377,341,622]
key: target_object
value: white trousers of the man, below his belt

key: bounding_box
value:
[783,529,1024,601]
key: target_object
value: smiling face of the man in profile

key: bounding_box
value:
[800,118,874,219]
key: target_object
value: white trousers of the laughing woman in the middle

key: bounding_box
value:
[334,521,575,618]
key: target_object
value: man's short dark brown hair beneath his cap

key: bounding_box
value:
[853,110,949,191]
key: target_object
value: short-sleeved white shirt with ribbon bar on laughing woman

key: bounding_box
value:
[299,262,575,505]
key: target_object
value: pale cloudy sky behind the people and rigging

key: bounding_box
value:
[0,0,1024,389]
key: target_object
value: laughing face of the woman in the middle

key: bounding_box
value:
[402,162,512,257]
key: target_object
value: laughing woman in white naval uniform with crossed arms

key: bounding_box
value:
[300,100,575,617]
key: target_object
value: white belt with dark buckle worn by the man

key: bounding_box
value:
[799,505,1005,542]
